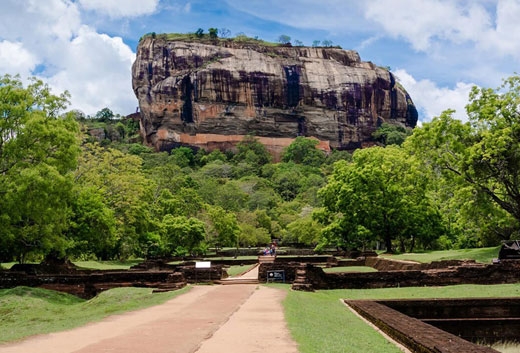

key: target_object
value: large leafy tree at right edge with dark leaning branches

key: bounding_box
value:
[405,76,520,244]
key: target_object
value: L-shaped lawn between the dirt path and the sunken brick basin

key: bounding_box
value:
[282,284,520,353]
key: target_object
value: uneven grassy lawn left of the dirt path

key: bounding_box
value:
[0,287,188,342]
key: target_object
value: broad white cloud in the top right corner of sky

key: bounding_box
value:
[365,0,520,59]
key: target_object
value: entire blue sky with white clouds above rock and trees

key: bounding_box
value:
[0,0,520,122]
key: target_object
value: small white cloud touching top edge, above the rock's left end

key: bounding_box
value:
[79,0,159,18]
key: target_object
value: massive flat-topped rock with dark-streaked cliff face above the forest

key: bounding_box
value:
[132,37,417,155]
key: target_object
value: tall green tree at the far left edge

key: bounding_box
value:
[0,75,79,262]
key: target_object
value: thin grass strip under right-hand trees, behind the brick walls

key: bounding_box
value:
[379,246,500,264]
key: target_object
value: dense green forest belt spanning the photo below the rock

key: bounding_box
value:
[0,75,520,262]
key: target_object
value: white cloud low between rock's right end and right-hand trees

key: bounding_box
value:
[395,69,475,121]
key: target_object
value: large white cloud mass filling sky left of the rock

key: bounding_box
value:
[0,0,137,114]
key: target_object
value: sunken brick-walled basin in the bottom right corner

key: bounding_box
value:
[346,298,520,346]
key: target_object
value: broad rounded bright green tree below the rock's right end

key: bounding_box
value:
[314,146,442,252]
